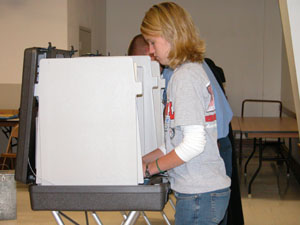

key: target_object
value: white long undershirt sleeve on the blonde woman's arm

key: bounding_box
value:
[175,125,206,162]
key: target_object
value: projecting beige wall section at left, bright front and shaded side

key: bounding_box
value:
[0,0,106,108]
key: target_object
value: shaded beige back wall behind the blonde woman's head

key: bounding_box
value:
[107,0,282,115]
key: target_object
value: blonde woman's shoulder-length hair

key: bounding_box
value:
[140,2,205,69]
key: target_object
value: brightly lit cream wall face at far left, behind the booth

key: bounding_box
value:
[0,0,68,108]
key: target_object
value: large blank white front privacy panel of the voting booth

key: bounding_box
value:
[37,57,142,185]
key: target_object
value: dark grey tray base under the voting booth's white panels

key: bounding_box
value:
[29,183,169,211]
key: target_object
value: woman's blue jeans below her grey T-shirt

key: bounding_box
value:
[174,188,230,225]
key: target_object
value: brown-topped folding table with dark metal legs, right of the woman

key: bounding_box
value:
[238,117,299,198]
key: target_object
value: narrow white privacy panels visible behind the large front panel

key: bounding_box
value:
[132,56,163,155]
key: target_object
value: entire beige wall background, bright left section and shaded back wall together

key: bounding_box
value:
[0,0,289,118]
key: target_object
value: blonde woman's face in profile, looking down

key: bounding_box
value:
[144,35,171,66]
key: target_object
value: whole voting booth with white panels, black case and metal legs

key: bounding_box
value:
[15,46,169,224]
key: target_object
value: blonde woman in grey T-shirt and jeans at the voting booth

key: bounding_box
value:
[141,2,230,225]
